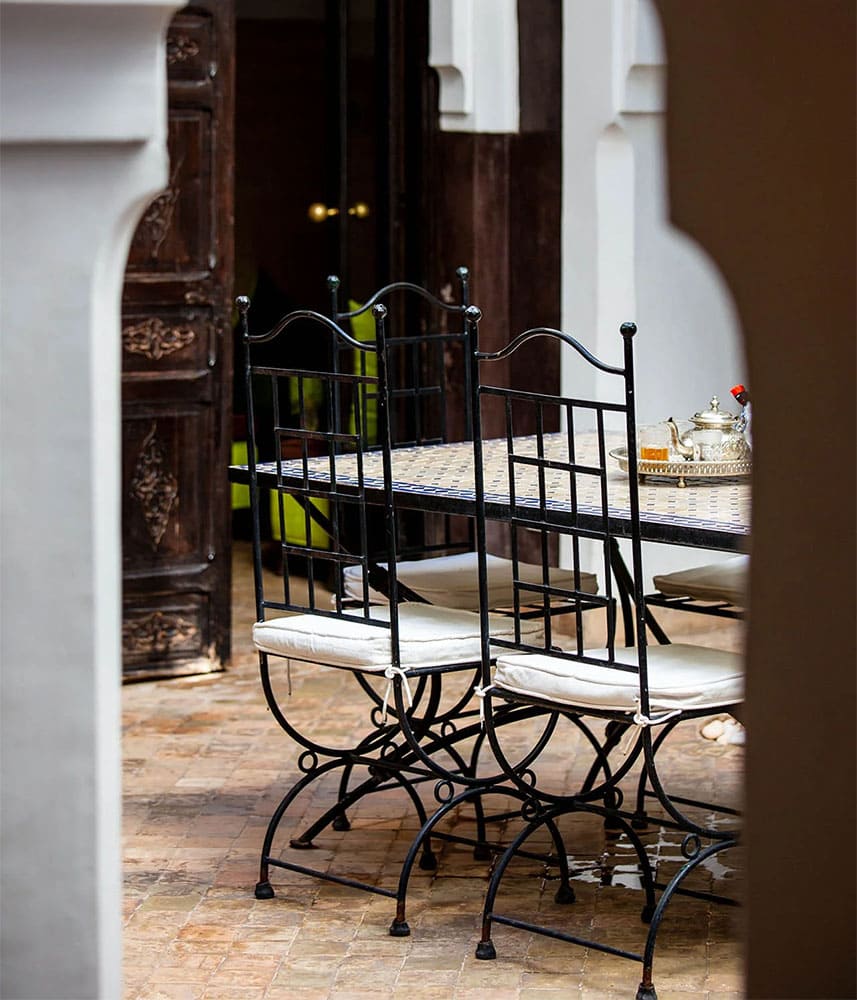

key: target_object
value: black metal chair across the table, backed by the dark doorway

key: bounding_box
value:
[327,267,598,611]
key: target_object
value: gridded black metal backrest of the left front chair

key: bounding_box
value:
[239,300,395,629]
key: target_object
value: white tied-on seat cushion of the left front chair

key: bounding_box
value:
[253,604,543,672]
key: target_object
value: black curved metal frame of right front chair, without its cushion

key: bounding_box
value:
[462,316,738,1000]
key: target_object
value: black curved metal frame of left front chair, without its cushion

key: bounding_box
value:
[237,294,568,899]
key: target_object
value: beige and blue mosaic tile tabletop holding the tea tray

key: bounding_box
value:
[239,434,750,549]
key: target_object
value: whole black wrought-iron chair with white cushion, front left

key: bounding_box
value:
[237,297,539,899]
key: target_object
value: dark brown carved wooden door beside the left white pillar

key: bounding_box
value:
[122,0,234,680]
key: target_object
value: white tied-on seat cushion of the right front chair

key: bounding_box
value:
[494,643,744,713]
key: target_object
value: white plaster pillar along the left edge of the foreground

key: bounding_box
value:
[0,0,180,1000]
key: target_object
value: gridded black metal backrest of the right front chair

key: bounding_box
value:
[472,324,648,688]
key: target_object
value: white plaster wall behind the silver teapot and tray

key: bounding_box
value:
[562,0,746,575]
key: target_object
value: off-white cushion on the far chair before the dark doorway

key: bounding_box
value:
[343,552,598,611]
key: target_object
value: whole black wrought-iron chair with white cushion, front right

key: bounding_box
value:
[462,323,743,1000]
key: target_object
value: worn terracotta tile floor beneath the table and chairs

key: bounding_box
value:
[123,543,743,1000]
